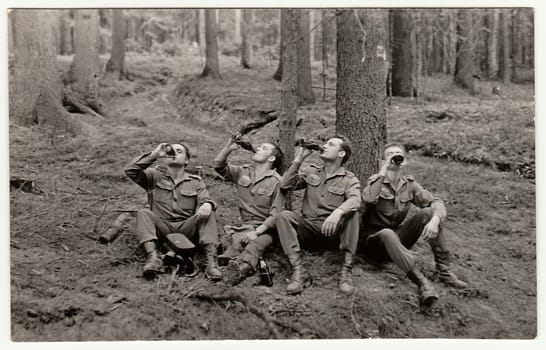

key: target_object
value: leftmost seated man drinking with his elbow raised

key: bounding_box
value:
[125,143,222,280]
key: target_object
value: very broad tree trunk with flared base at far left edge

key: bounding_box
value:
[9,9,74,131]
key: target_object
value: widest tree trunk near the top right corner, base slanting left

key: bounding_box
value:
[453,9,474,92]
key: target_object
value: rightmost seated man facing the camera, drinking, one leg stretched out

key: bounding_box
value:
[359,143,468,306]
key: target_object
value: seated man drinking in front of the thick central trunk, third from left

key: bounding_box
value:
[275,136,361,294]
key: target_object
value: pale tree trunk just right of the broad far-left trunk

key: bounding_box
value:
[70,10,101,113]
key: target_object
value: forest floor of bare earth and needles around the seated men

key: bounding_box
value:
[10,47,537,341]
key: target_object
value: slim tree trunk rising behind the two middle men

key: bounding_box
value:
[279,9,298,172]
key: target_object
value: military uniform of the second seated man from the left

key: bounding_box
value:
[213,161,283,268]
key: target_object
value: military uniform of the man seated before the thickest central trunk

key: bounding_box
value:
[275,162,361,257]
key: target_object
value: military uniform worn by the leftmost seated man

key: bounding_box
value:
[125,153,218,246]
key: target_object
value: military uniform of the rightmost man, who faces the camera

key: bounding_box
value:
[359,174,447,273]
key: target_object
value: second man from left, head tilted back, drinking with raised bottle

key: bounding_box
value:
[214,137,283,285]
